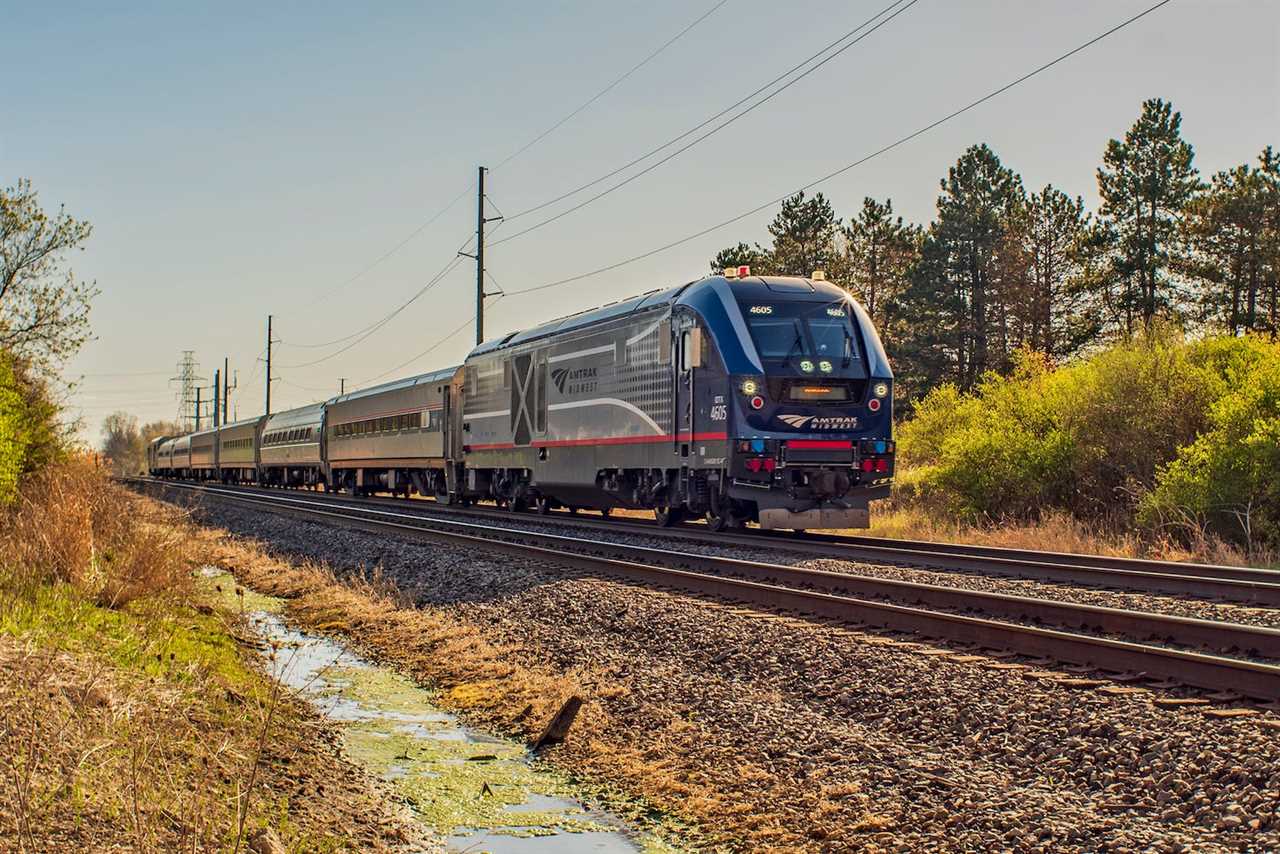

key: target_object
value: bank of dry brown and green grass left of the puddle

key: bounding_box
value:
[0,463,424,853]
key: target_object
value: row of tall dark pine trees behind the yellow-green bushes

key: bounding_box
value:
[710,99,1280,403]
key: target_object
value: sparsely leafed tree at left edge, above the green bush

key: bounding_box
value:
[0,178,97,371]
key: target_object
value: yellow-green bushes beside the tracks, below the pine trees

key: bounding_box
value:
[899,332,1280,540]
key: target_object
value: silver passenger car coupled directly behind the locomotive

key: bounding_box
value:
[325,367,461,498]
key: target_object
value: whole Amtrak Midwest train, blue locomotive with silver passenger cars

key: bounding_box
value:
[147,268,895,530]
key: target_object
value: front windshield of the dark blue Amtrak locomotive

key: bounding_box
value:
[742,302,867,378]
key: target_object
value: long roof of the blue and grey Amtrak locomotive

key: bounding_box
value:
[467,275,845,359]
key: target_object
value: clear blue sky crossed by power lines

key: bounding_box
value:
[0,0,1280,439]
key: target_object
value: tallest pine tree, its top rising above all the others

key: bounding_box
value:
[1098,99,1201,334]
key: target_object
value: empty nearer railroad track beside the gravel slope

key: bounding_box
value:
[132,483,1280,700]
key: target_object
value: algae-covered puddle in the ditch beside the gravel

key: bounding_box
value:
[205,571,677,854]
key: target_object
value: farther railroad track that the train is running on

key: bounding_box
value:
[127,479,1280,607]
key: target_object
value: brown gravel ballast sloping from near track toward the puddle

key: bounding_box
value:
[189,503,1280,851]
